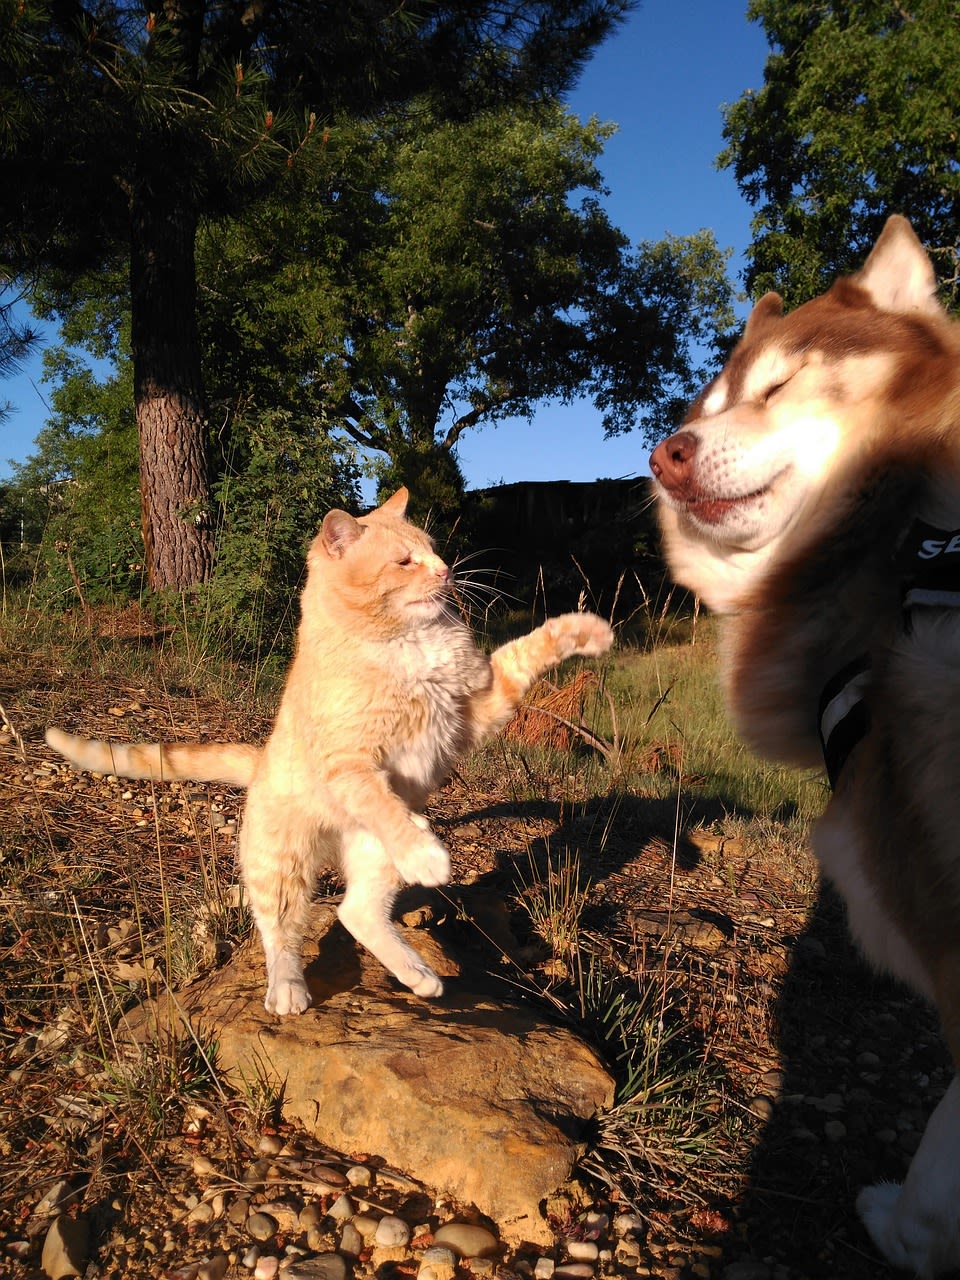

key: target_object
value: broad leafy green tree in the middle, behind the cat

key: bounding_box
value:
[200,101,733,515]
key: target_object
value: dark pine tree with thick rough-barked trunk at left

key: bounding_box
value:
[0,0,627,588]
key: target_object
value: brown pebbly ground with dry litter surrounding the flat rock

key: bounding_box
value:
[0,652,948,1280]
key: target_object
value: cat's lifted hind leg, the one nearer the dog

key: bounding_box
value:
[338,831,443,996]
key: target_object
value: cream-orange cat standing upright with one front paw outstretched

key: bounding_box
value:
[46,490,612,1014]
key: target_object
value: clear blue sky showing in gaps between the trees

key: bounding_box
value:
[0,0,768,488]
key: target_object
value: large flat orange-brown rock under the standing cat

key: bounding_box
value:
[126,904,613,1242]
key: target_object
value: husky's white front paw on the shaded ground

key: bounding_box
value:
[856,1183,960,1276]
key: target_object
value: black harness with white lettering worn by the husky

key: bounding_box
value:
[817,520,960,790]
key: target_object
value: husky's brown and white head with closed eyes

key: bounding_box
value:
[650,216,956,612]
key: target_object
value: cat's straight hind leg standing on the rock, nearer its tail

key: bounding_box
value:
[238,786,321,1015]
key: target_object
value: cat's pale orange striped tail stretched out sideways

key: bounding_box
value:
[46,728,260,787]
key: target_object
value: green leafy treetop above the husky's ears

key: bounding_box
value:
[719,0,960,303]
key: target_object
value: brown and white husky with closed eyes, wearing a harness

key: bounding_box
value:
[650,216,960,1277]
